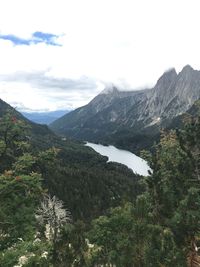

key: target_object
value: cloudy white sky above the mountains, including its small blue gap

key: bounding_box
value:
[0,0,200,111]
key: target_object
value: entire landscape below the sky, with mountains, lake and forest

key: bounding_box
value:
[0,66,200,267]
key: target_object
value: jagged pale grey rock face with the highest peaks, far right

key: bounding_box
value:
[142,66,200,122]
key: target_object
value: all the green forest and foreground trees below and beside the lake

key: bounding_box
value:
[0,103,200,267]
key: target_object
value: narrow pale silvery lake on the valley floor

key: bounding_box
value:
[86,142,150,176]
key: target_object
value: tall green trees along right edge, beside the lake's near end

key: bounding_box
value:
[141,117,200,266]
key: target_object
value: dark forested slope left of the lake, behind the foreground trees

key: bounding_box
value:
[0,99,141,221]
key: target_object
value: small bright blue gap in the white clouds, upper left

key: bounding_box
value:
[0,31,61,46]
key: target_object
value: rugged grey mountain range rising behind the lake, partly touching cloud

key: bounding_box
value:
[50,65,200,152]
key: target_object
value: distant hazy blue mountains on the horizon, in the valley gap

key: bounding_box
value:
[22,110,69,125]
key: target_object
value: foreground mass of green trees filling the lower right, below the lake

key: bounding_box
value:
[89,111,200,267]
